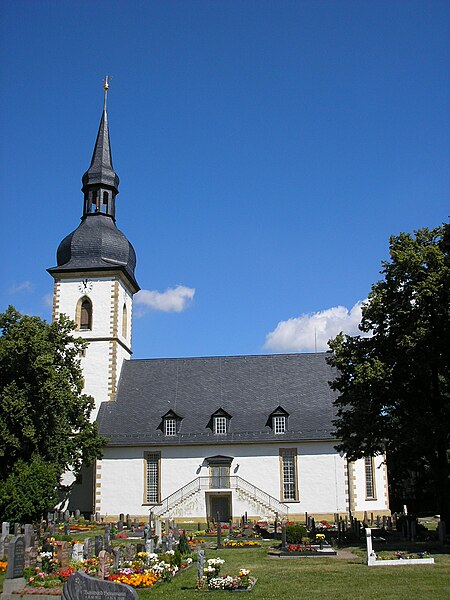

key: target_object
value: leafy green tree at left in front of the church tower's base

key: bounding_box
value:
[0,307,106,520]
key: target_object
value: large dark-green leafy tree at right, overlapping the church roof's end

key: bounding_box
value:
[329,224,450,525]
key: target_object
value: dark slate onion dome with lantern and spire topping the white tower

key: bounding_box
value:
[48,77,139,293]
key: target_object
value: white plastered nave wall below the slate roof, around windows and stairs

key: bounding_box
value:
[97,442,358,519]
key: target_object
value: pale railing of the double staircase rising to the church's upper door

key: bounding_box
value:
[153,475,289,518]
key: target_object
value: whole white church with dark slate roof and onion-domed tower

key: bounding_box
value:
[48,91,390,522]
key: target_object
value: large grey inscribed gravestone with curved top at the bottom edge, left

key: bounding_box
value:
[62,572,138,600]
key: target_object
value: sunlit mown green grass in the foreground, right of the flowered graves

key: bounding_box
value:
[138,548,450,600]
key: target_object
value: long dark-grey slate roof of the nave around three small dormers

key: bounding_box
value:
[97,353,336,446]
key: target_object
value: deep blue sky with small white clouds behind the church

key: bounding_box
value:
[0,0,450,358]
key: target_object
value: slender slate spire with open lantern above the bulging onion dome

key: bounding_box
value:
[81,76,119,219]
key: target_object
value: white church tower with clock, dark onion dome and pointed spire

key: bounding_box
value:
[48,78,139,419]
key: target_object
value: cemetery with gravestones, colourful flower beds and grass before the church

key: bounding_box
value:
[0,511,450,600]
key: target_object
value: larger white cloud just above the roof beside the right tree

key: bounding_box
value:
[264,301,370,352]
